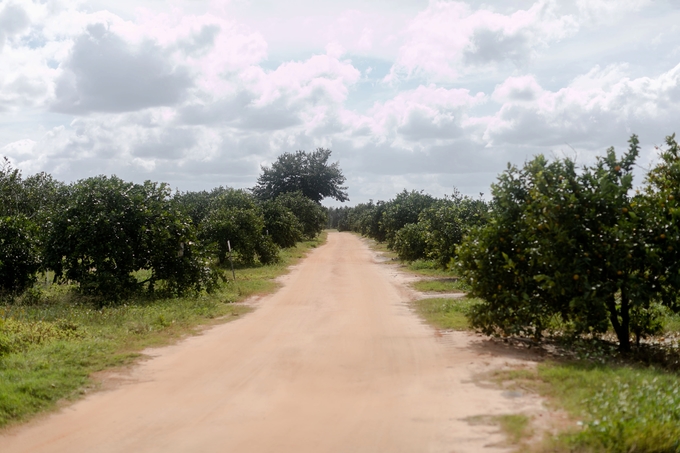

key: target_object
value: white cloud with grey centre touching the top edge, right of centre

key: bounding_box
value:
[387,0,577,80]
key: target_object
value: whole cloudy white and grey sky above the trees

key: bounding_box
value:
[0,0,680,205]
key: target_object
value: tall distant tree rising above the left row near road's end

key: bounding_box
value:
[253,148,349,203]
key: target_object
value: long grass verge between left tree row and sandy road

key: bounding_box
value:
[0,234,326,427]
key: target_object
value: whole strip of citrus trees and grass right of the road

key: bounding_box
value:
[338,132,680,453]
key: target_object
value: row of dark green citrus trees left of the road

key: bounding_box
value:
[0,157,330,300]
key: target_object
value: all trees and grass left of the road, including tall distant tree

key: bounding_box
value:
[0,149,346,427]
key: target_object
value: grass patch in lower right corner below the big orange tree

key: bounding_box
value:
[492,361,680,453]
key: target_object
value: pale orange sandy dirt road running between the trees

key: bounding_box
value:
[0,233,541,453]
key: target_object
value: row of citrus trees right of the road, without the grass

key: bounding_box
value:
[332,132,680,351]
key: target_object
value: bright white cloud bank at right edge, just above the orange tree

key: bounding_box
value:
[485,61,680,148]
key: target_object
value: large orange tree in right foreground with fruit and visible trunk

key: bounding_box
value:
[460,136,677,351]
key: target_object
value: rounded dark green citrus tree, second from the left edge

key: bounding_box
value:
[45,176,214,300]
